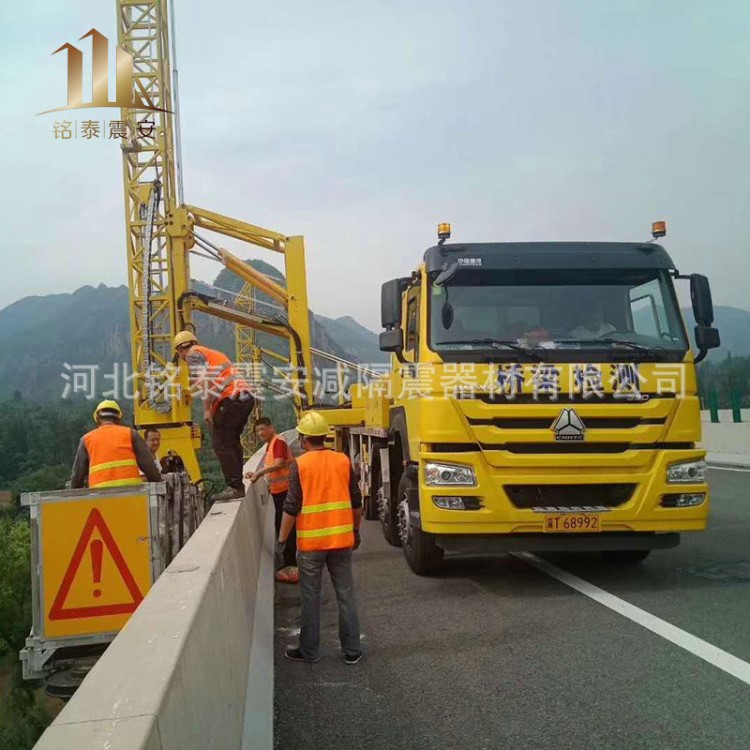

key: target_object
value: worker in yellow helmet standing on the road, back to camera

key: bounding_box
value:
[276,411,362,664]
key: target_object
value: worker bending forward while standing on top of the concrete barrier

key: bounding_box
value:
[174,331,255,502]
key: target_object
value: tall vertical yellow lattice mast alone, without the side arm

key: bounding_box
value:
[117,0,200,470]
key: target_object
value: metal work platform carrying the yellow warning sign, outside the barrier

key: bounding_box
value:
[20,472,205,697]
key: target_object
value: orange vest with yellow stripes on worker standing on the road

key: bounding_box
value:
[297,450,354,552]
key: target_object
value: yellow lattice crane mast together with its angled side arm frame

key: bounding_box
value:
[116,0,313,481]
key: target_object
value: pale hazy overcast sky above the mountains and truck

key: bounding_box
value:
[0,0,750,330]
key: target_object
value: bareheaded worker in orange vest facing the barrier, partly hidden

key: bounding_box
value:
[245,417,299,583]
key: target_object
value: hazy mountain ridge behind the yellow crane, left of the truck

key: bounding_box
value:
[0,261,376,402]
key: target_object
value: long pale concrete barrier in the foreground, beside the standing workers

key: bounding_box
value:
[36,455,274,750]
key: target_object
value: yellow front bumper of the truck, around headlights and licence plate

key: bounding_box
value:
[419,449,710,536]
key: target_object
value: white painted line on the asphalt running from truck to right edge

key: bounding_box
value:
[511,552,750,685]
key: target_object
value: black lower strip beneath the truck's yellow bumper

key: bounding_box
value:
[436,532,680,555]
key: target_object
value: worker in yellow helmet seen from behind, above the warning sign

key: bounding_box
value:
[70,401,161,489]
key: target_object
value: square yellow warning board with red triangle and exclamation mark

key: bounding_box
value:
[40,494,152,638]
